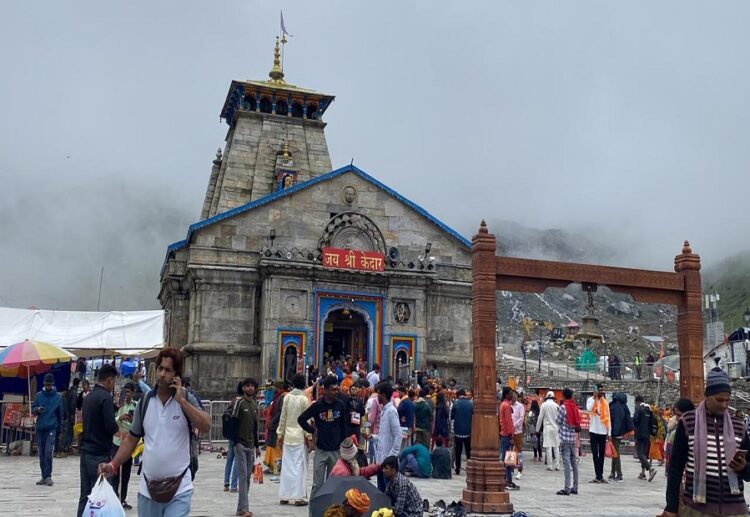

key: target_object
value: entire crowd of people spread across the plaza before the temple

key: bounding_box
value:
[25,349,750,517]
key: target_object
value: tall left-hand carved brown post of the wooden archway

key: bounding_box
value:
[463,221,513,514]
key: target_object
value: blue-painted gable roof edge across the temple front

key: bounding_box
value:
[162,165,471,272]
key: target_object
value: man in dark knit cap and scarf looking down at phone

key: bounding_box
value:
[661,368,750,517]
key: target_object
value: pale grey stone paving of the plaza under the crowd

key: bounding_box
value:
[0,453,728,517]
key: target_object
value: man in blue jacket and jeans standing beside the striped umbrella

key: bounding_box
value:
[31,373,63,486]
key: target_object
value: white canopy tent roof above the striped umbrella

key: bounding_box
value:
[0,307,164,356]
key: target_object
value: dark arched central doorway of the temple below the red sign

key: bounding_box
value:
[323,309,368,367]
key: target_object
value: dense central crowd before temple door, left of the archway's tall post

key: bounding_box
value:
[219,358,473,517]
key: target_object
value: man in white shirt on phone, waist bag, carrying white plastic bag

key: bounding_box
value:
[99,348,211,517]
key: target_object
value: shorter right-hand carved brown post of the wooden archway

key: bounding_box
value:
[674,241,704,405]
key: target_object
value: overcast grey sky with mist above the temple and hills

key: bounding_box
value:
[0,0,750,310]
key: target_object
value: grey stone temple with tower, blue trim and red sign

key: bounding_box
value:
[159,41,472,399]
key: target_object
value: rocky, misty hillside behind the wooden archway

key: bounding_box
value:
[482,221,750,362]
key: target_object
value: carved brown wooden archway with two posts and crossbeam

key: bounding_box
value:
[463,221,703,513]
